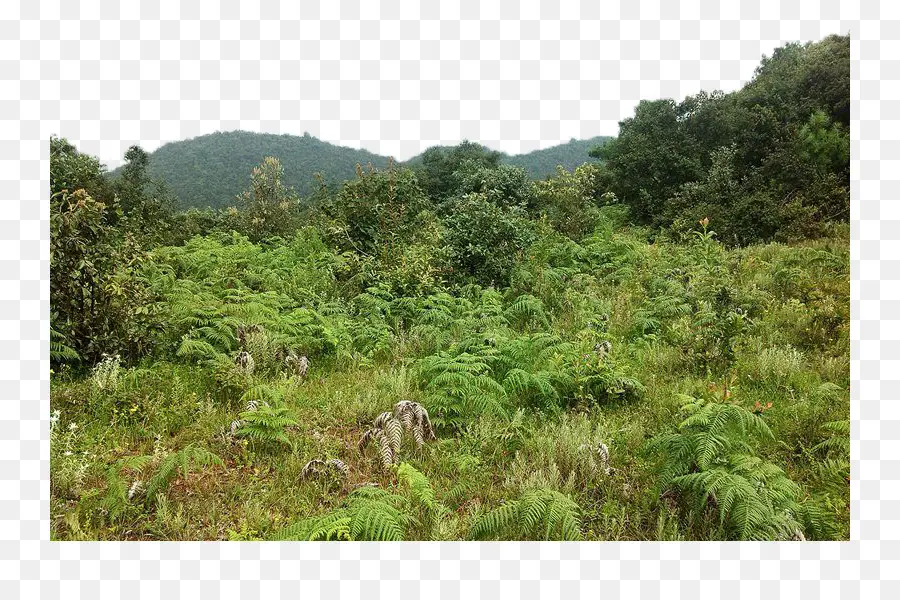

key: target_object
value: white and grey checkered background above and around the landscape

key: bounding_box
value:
[0,0,900,598]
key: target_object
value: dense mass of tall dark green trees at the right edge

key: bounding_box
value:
[592,36,850,244]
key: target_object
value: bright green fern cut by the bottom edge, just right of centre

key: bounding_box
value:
[469,488,582,541]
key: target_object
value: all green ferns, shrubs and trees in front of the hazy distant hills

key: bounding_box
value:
[50,36,850,541]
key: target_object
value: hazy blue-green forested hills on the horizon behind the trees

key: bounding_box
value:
[111,131,611,209]
